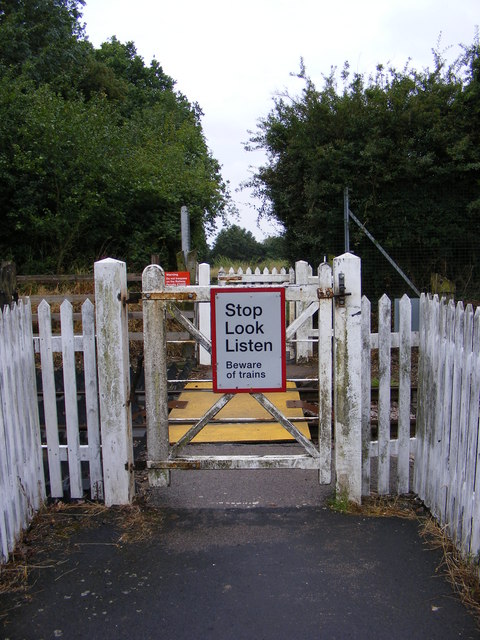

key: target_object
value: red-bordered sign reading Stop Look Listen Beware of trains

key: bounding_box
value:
[210,287,287,393]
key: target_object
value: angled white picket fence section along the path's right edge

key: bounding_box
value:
[414,295,480,559]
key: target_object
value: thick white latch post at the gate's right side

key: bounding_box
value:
[333,253,362,503]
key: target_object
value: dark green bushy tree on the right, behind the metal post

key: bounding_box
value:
[250,41,480,300]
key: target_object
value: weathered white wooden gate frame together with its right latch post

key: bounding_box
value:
[129,254,362,502]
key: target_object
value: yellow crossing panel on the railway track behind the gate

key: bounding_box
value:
[169,381,310,443]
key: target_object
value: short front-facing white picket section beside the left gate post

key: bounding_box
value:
[34,300,103,500]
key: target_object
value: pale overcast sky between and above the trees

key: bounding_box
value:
[83,0,480,240]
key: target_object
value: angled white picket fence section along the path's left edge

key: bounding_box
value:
[0,302,45,561]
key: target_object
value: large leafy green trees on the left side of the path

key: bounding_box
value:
[0,0,228,273]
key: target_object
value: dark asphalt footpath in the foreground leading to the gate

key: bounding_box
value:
[0,445,480,640]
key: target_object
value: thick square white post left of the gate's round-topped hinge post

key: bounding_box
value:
[95,258,134,506]
